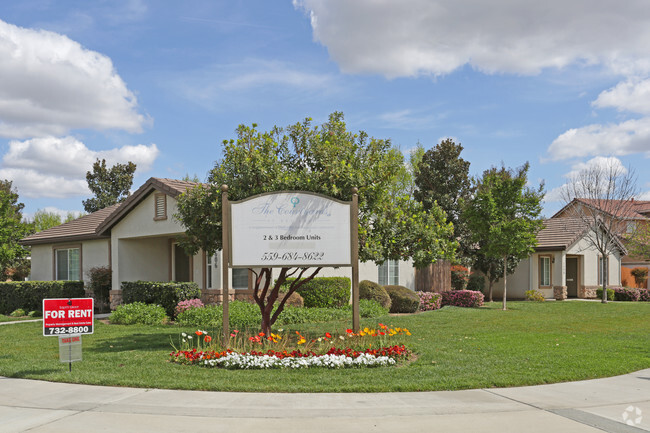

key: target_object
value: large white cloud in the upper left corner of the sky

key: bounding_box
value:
[0,20,148,138]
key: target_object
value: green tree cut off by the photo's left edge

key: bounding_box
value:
[0,180,33,281]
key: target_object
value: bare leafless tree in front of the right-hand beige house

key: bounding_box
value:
[561,160,642,303]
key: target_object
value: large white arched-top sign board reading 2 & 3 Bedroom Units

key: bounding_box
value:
[230,192,352,268]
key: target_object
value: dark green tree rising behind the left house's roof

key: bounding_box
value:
[83,159,136,213]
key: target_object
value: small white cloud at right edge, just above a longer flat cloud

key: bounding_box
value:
[593,78,650,114]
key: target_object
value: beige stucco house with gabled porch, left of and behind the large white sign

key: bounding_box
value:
[21,177,415,307]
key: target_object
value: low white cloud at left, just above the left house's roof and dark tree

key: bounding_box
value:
[0,137,159,198]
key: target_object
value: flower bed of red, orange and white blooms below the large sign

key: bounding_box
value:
[169,323,411,370]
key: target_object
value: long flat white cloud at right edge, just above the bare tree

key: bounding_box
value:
[548,117,650,160]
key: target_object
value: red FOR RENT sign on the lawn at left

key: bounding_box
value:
[43,298,94,336]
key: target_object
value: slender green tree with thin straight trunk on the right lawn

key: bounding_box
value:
[464,163,544,310]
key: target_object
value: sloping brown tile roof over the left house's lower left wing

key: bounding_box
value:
[20,203,121,245]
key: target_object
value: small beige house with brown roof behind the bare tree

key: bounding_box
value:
[486,217,627,299]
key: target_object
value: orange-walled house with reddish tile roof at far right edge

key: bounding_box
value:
[552,198,650,288]
